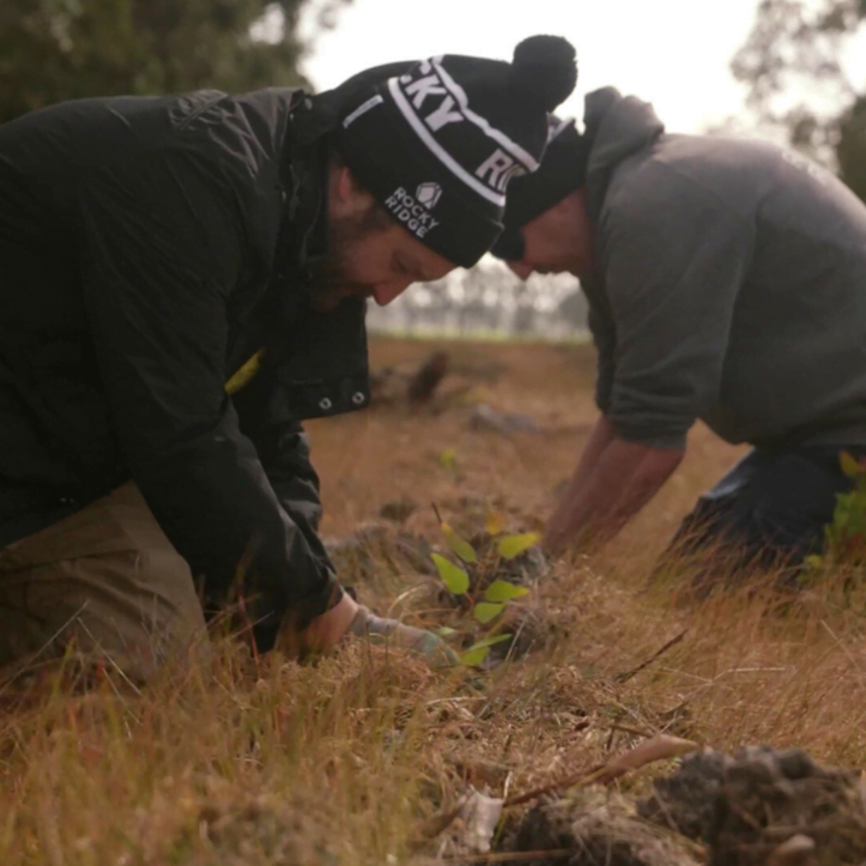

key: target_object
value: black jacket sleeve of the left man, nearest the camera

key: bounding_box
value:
[80,153,339,650]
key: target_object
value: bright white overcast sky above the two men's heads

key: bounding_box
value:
[304,0,757,132]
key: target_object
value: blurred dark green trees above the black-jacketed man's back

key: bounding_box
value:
[0,0,351,123]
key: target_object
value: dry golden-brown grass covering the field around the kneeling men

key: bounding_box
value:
[0,341,866,866]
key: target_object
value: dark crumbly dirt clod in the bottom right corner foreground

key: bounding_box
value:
[638,747,866,866]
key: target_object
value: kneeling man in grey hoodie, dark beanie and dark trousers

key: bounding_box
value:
[494,88,866,588]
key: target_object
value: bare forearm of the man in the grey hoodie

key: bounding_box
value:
[545,416,685,552]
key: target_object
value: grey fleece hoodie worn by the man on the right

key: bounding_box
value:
[584,88,866,448]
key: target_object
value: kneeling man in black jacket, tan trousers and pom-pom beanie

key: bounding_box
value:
[0,37,576,679]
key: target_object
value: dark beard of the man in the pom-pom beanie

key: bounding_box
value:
[310,209,381,313]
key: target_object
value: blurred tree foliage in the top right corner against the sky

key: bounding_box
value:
[731,0,866,200]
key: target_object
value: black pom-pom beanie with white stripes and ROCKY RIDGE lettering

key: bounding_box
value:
[337,36,577,268]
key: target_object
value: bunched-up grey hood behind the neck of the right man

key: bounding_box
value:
[583,87,665,219]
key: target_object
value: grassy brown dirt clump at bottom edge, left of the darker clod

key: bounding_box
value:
[505,796,700,866]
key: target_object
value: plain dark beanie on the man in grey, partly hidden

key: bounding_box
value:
[491,117,589,261]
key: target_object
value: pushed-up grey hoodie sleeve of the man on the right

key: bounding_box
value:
[603,165,753,449]
